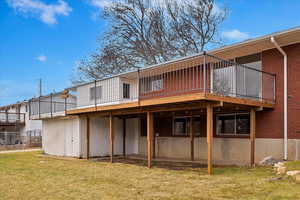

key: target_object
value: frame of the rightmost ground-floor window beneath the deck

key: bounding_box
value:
[216,112,251,136]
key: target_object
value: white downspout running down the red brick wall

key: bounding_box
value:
[271,36,288,160]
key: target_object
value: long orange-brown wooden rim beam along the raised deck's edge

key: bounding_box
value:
[66,92,274,115]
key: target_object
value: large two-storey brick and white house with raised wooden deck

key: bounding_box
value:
[30,27,300,173]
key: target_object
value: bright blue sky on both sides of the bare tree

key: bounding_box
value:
[0,0,300,105]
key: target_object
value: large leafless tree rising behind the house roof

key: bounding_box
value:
[73,0,227,81]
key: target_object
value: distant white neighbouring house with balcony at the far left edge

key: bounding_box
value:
[0,101,42,149]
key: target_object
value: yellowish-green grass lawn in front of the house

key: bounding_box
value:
[0,152,300,200]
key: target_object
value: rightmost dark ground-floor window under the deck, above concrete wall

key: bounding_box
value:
[217,113,250,135]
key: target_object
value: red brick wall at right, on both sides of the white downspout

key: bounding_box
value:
[256,44,300,139]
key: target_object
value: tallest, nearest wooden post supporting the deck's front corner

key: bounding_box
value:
[206,104,213,175]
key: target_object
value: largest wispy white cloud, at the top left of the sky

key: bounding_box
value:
[6,0,72,24]
